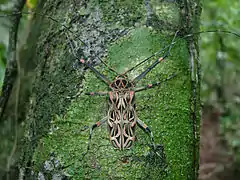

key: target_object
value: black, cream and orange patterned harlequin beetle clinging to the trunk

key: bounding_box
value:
[66,31,178,150]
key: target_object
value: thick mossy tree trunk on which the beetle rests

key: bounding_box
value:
[0,0,200,180]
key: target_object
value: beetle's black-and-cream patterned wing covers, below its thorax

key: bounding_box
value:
[108,91,136,149]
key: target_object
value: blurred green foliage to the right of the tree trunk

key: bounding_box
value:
[200,0,240,169]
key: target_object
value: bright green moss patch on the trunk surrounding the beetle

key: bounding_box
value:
[34,28,193,179]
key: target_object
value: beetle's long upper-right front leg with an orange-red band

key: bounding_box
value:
[132,31,178,84]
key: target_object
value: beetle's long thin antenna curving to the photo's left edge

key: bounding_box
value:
[0,11,119,75]
